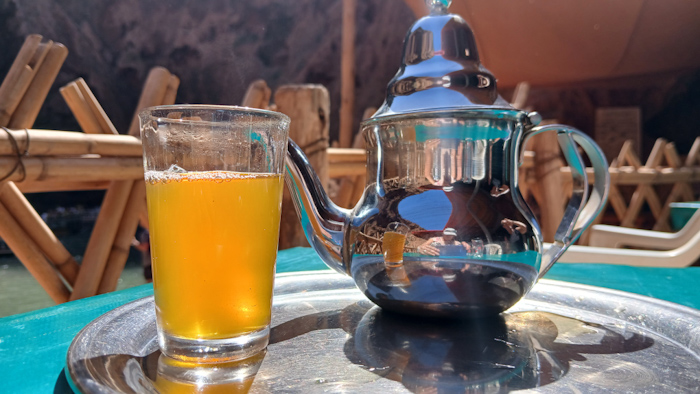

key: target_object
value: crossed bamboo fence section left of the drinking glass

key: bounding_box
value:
[0,35,179,303]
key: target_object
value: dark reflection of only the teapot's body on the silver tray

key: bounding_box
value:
[346,309,544,392]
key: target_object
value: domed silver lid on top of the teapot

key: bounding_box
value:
[373,0,514,118]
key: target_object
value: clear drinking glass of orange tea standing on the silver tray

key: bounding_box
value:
[139,105,289,362]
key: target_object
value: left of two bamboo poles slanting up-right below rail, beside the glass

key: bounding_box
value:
[70,181,133,301]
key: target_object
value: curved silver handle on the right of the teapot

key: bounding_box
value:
[522,124,610,278]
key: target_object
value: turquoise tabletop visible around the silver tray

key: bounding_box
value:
[0,248,700,393]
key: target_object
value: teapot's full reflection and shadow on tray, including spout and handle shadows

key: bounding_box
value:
[271,302,654,392]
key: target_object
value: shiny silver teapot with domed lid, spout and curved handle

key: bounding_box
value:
[286,0,610,318]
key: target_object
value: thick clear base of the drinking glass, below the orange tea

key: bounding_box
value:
[158,326,270,363]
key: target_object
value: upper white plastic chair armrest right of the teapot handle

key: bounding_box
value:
[589,209,700,250]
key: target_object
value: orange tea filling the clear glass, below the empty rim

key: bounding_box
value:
[146,171,283,339]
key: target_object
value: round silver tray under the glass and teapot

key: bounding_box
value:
[66,272,700,393]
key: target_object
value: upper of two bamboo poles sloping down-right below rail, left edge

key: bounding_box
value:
[0,182,79,285]
